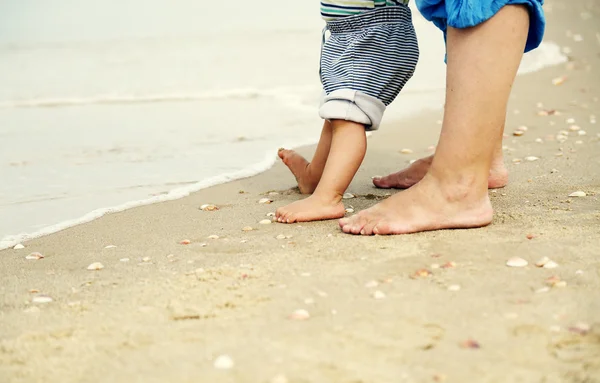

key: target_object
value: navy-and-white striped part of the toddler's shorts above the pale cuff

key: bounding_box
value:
[320,5,419,106]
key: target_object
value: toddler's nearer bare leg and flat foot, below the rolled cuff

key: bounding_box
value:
[276,120,367,223]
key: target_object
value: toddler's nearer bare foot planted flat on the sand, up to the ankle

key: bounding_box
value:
[275,194,345,223]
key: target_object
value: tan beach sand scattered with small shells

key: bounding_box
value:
[0,1,600,383]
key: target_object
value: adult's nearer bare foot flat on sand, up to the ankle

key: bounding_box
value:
[339,176,493,235]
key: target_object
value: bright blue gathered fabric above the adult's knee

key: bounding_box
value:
[416,0,546,52]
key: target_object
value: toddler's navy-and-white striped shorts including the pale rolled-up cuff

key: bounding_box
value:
[319,5,419,130]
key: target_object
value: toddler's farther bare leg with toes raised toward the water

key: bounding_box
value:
[278,120,332,194]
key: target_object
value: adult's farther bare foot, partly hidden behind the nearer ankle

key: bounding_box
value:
[373,156,508,189]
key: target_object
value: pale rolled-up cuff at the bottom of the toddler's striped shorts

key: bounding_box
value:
[319,89,385,130]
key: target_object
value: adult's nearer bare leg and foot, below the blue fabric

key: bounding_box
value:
[340,5,529,235]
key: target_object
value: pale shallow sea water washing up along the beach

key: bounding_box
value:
[0,0,565,249]
